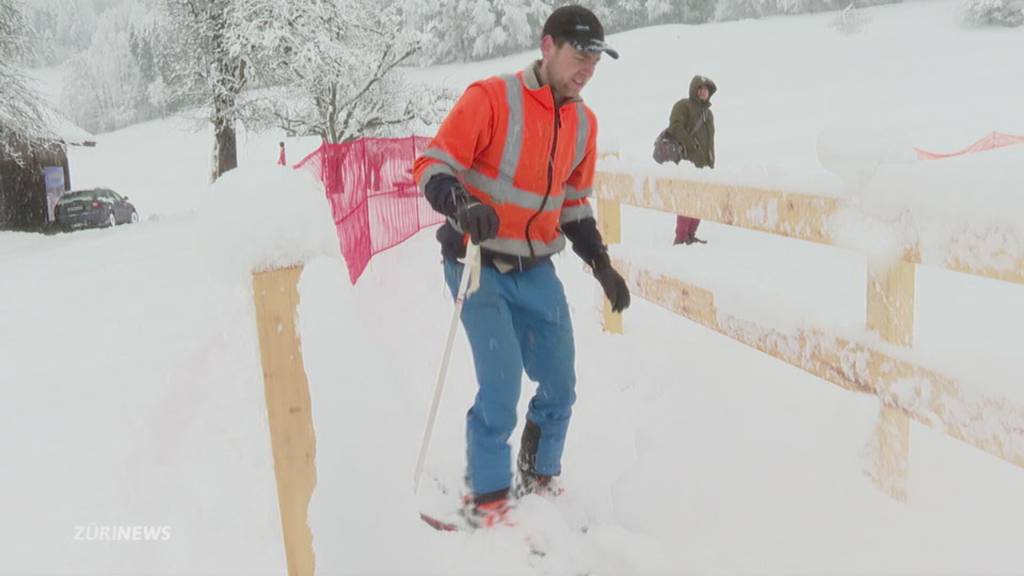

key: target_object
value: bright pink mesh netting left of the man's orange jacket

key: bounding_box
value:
[295,136,443,284]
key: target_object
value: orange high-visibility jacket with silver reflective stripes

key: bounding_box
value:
[414,63,597,257]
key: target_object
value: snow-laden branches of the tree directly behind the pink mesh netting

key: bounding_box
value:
[239,0,450,142]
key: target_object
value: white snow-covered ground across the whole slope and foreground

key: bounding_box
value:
[0,1,1024,575]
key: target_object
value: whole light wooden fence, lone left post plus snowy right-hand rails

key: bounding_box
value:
[243,167,1024,576]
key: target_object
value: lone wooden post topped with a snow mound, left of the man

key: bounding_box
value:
[253,266,316,576]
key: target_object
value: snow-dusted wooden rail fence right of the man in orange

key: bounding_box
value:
[594,171,1024,501]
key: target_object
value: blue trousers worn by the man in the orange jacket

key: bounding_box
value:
[444,259,575,494]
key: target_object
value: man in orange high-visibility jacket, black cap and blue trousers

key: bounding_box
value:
[415,6,630,526]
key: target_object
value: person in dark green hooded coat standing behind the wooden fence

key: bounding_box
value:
[665,75,718,244]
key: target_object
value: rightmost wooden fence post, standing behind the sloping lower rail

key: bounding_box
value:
[867,261,916,502]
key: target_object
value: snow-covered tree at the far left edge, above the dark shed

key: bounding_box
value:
[0,0,52,158]
